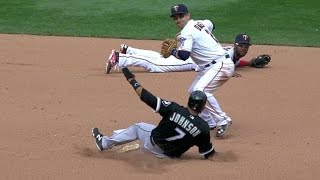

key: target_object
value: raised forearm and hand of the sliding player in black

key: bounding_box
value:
[122,68,160,110]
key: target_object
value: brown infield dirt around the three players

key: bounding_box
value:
[0,34,320,180]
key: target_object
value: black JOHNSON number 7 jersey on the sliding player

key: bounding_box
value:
[141,90,214,157]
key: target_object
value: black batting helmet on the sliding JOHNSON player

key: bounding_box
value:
[188,91,207,113]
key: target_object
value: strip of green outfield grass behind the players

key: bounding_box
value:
[0,0,320,47]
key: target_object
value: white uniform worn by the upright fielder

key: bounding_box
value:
[178,19,234,128]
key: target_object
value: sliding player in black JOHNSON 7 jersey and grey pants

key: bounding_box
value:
[92,68,215,159]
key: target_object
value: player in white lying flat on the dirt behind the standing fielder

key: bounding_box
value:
[106,33,271,76]
